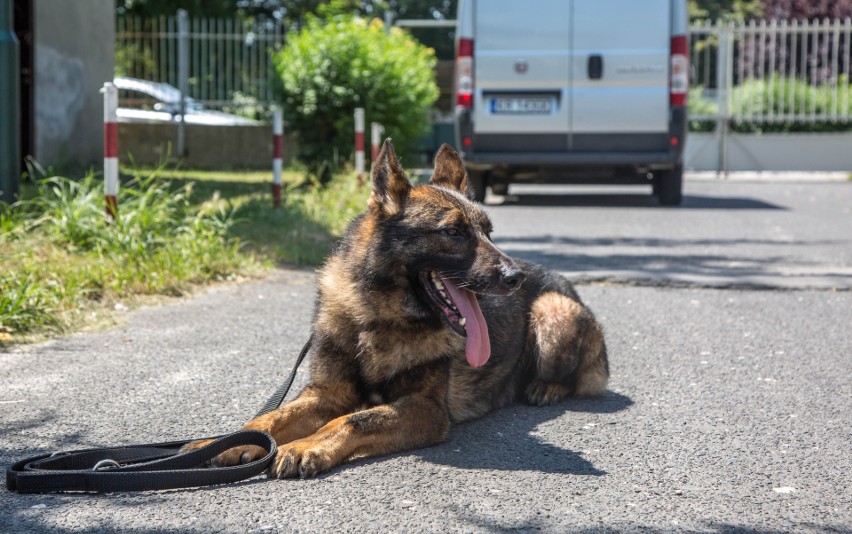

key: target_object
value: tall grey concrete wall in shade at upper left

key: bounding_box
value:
[34,0,115,165]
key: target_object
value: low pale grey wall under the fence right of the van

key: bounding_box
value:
[684,132,852,171]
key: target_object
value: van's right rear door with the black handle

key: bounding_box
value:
[572,0,671,152]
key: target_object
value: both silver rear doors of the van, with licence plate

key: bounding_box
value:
[472,0,671,152]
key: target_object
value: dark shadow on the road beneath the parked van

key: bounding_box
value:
[489,193,788,210]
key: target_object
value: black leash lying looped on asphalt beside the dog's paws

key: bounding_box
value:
[6,336,313,493]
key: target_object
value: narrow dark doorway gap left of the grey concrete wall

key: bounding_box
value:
[12,0,35,170]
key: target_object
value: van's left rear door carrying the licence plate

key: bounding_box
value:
[473,0,572,152]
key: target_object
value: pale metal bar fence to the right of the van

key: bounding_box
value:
[690,19,852,125]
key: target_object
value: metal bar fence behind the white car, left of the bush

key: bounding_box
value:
[116,15,284,110]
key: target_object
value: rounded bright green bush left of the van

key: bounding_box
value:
[275,15,439,180]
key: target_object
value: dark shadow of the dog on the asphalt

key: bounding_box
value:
[417,391,633,476]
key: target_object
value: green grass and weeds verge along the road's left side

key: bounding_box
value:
[0,168,368,345]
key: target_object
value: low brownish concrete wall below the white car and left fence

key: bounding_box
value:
[118,123,296,169]
